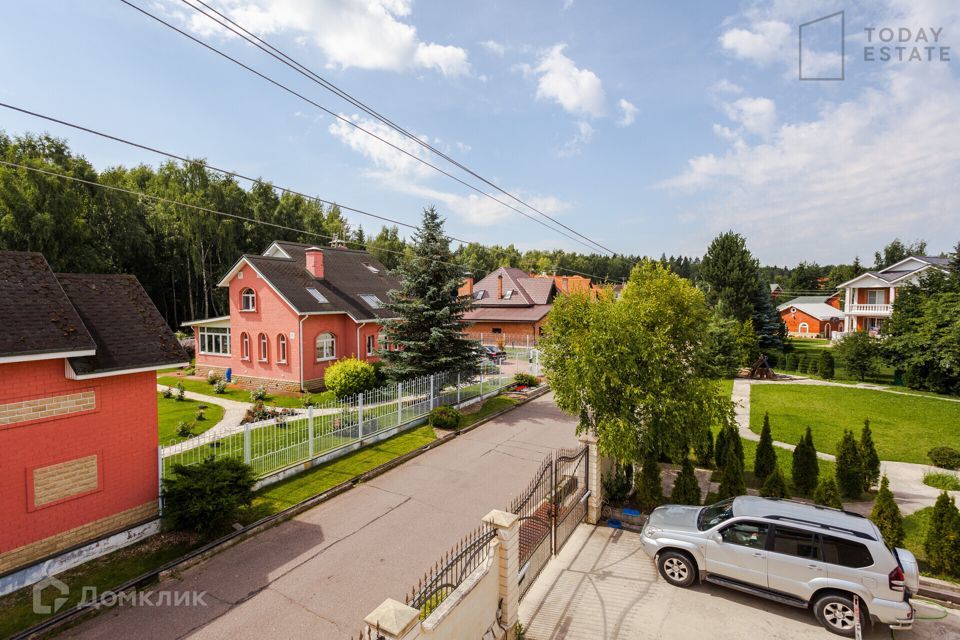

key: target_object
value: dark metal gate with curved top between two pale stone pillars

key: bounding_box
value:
[508,446,589,598]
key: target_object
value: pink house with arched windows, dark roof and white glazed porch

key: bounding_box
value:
[185,241,399,391]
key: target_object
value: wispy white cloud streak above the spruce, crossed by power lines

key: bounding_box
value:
[329,115,570,226]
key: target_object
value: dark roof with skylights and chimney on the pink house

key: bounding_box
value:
[244,241,400,320]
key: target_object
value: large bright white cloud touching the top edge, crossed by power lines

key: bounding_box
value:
[170,0,470,76]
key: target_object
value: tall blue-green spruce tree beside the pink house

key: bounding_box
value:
[381,207,480,380]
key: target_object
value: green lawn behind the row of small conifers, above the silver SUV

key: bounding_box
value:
[750,384,960,464]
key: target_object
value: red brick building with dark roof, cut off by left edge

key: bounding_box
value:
[0,251,189,592]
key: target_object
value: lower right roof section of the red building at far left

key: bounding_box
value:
[57,273,190,375]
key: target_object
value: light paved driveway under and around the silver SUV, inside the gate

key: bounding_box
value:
[520,525,960,640]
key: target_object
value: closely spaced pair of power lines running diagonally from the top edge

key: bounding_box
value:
[181,0,616,255]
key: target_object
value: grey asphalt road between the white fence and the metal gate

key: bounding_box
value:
[63,395,577,640]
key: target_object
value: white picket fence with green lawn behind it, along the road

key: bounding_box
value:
[159,363,512,481]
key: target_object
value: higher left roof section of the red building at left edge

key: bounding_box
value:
[0,251,96,357]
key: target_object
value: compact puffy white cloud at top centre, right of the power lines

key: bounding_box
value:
[533,44,606,117]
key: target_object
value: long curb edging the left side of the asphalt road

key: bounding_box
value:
[9,384,550,640]
